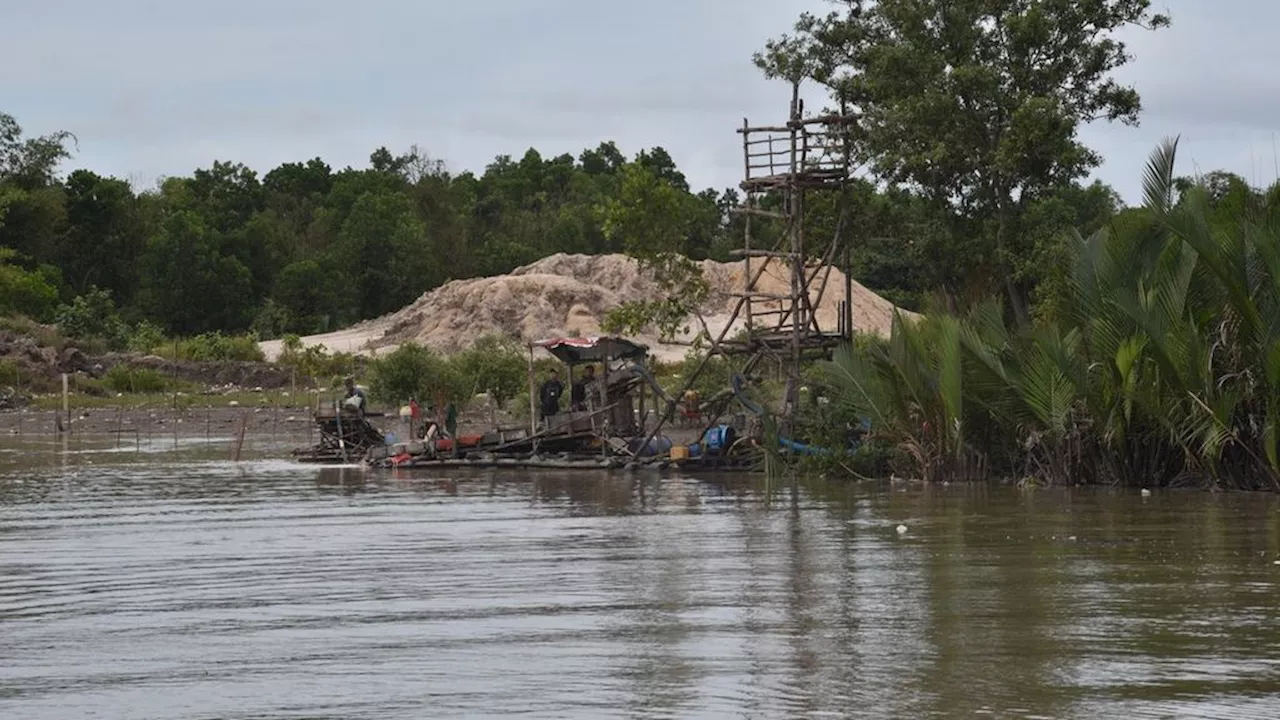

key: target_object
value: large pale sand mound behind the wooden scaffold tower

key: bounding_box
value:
[262,254,916,360]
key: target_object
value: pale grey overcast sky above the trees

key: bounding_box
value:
[0,0,1280,201]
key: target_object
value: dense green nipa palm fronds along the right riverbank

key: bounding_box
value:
[824,142,1280,489]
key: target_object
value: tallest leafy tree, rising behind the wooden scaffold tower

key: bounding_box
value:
[755,0,1169,318]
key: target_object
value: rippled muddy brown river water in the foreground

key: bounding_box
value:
[0,427,1280,720]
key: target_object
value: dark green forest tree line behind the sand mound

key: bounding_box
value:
[0,114,1116,345]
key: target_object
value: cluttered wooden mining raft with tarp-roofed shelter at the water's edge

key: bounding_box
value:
[294,336,759,470]
